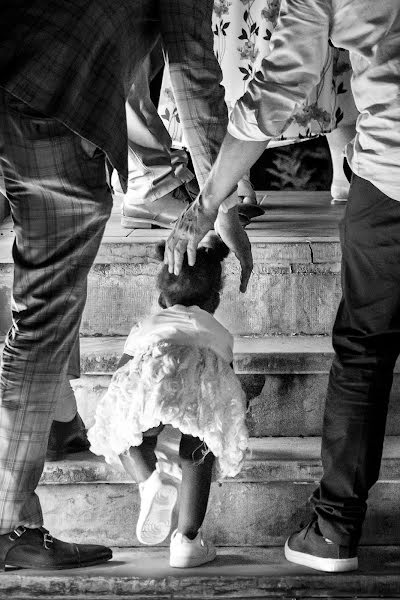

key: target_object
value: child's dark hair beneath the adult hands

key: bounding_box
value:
[157,238,229,313]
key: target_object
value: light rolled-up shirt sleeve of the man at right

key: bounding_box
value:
[228,0,332,142]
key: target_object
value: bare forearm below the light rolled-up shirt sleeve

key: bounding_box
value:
[200,133,267,211]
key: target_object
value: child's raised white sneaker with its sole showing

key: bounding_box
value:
[136,471,178,546]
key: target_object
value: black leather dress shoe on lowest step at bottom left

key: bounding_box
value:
[0,526,112,570]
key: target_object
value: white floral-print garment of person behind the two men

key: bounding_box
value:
[159,0,358,145]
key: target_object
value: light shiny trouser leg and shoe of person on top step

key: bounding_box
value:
[116,54,193,228]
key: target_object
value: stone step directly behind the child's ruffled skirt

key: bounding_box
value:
[75,336,400,437]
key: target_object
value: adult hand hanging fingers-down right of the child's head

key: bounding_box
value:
[215,207,253,292]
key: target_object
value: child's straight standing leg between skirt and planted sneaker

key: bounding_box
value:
[178,434,215,540]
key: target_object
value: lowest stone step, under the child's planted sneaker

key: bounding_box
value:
[0,546,400,600]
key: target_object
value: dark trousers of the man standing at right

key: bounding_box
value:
[312,175,400,544]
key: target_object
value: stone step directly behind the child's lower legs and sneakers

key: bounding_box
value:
[38,437,400,547]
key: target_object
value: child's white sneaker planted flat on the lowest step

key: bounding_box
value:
[169,530,217,569]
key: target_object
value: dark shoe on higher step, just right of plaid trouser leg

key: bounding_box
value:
[46,413,90,461]
